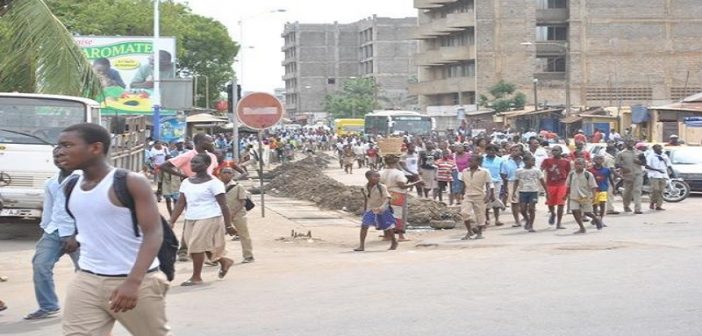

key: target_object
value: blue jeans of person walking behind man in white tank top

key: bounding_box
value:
[32,230,79,311]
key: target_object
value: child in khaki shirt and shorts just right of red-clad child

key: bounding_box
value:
[563,158,602,234]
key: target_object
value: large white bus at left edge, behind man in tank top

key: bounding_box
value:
[0,93,144,219]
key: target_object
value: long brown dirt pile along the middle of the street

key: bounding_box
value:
[264,154,460,226]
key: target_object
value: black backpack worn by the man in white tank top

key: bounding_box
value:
[64,168,179,281]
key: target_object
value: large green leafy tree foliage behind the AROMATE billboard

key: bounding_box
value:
[0,0,239,106]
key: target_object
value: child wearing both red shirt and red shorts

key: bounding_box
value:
[541,146,570,229]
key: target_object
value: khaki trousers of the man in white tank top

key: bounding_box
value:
[63,271,171,336]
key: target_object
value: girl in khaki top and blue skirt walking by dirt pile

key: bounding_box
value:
[354,170,397,252]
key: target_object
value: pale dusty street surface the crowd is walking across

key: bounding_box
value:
[0,164,702,336]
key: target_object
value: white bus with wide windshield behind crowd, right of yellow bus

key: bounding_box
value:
[365,111,434,136]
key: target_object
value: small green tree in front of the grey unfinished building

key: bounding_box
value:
[324,78,377,118]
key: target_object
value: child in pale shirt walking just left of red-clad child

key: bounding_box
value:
[514,155,548,232]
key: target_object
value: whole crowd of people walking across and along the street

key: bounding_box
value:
[0,119,674,335]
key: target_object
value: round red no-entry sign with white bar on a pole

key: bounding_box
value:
[236,92,285,129]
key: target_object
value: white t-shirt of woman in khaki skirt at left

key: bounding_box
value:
[180,178,225,220]
